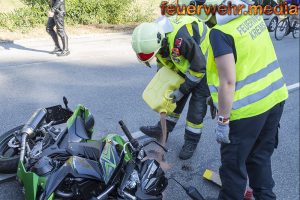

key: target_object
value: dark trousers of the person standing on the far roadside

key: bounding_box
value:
[46,14,68,49]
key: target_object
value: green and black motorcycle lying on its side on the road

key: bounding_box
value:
[0,97,168,200]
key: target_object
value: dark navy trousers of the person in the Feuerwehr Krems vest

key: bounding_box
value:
[219,102,284,200]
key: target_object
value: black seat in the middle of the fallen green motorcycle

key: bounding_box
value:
[67,141,104,161]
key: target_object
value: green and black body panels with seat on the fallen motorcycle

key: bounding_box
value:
[17,105,131,200]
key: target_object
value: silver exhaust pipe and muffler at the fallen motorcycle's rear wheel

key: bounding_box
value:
[20,108,47,162]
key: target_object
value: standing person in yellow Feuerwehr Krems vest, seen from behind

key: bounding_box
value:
[200,0,288,200]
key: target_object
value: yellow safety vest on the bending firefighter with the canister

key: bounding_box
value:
[156,15,209,76]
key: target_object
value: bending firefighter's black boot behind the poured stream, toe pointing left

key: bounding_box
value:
[140,120,176,140]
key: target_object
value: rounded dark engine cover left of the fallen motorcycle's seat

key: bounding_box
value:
[31,156,55,176]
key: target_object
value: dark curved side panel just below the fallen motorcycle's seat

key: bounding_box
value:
[44,156,103,199]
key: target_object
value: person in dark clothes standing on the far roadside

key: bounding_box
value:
[46,0,70,56]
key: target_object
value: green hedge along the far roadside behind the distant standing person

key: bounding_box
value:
[0,0,160,31]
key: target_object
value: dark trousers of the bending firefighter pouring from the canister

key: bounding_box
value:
[169,76,210,142]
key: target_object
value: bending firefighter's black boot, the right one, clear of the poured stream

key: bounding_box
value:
[179,130,201,160]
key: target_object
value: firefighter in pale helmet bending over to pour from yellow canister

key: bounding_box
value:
[132,16,210,160]
